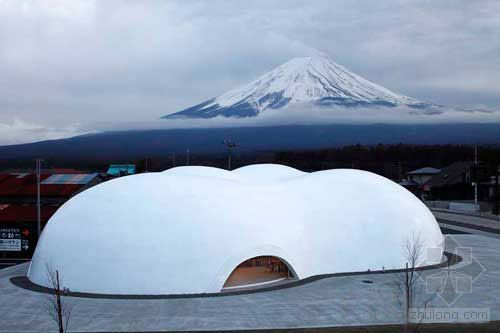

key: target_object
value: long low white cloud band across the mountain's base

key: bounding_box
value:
[0,104,500,145]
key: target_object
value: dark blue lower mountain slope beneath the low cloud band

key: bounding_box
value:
[0,123,500,163]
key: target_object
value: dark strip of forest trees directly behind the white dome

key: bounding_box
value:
[128,144,500,180]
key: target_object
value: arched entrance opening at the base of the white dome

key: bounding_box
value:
[222,256,295,291]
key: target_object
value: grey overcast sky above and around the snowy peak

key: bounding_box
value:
[0,0,500,144]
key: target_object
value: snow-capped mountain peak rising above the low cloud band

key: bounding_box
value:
[163,54,434,118]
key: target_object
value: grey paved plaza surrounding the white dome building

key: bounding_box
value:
[0,214,500,332]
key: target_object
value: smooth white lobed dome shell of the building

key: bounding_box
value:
[28,165,442,294]
